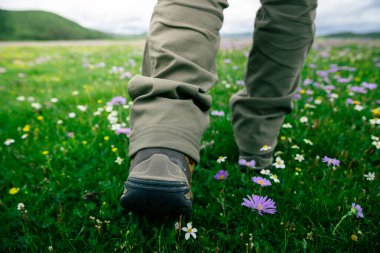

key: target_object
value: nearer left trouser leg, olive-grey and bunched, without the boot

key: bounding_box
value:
[128,0,228,162]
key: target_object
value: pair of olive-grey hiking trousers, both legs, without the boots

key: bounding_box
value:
[128,0,317,167]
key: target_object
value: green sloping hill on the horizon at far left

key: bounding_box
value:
[0,10,113,40]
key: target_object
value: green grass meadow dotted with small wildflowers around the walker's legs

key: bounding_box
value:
[0,40,380,252]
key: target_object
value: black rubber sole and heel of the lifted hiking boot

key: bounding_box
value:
[120,177,192,216]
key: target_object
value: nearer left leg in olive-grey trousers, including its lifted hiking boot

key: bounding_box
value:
[120,0,228,215]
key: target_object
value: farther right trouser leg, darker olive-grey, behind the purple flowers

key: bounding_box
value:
[230,0,317,167]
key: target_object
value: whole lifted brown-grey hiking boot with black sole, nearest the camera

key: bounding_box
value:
[120,148,195,216]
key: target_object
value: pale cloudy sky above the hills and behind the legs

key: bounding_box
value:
[0,0,380,35]
